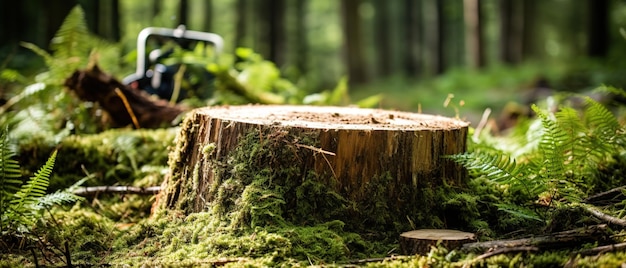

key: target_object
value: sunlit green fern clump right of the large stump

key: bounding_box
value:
[450,91,626,228]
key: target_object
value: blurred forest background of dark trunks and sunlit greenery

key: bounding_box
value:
[0,0,626,115]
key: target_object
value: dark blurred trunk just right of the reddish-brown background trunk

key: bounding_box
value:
[499,0,520,64]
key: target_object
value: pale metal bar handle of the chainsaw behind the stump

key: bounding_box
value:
[122,25,224,84]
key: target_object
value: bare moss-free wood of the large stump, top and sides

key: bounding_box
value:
[157,105,468,230]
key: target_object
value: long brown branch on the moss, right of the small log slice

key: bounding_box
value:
[461,224,608,252]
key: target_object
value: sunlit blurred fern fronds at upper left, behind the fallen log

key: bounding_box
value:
[0,6,119,141]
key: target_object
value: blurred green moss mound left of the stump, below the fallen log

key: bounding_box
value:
[18,128,178,191]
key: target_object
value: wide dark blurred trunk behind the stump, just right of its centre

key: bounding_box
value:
[341,0,367,84]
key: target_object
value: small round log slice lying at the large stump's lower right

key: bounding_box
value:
[400,229,476,255]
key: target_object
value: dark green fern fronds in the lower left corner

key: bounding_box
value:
[0,127,84,265]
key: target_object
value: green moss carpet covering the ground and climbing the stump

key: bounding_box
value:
[0,124,626,267]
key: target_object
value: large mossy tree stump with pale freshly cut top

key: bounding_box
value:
[155,105,468,232]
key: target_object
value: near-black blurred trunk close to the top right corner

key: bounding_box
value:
[587,0,610,57]
